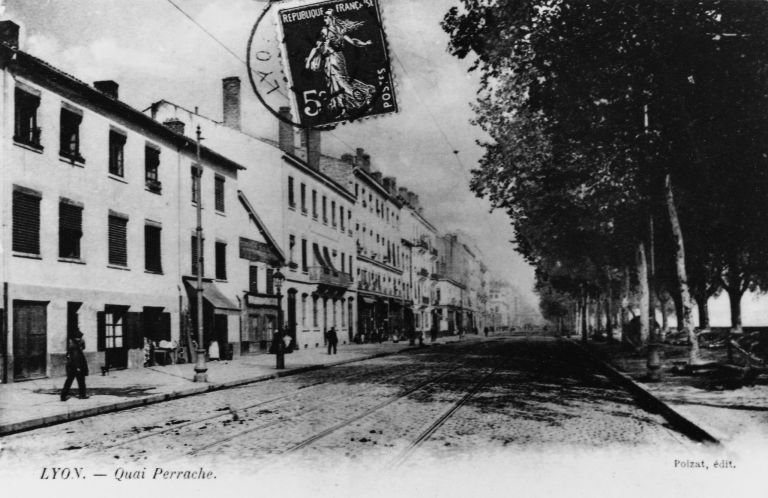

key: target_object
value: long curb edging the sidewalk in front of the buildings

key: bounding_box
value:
[0,342,462,437]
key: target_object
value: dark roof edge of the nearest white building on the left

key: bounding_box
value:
[0,43,245,171]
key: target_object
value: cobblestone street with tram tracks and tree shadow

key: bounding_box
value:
[0,338,693,471]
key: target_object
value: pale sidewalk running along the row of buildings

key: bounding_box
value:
[0,336,480,436]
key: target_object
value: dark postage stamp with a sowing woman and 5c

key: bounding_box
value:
[277,0,397,127]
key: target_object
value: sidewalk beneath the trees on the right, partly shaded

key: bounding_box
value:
[572,337,768,446]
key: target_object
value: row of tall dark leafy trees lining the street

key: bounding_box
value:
[443,0,768,359]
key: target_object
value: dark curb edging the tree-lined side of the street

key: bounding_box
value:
[561,338,722,445]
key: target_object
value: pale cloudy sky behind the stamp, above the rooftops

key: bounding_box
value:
[0,0,537,310]
